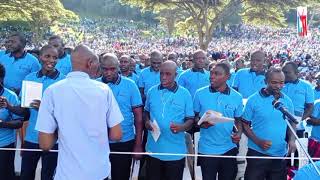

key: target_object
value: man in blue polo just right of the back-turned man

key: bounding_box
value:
[98,53,143,180]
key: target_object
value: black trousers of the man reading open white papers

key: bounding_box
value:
[198,148,238,180]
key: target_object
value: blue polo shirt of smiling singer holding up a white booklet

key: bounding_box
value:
[20,70,65,144]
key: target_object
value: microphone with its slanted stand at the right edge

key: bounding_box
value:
[272,101,320,176]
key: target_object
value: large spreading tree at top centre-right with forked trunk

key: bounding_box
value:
[120,0,318,49]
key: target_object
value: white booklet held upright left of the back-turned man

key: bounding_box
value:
[21,81,43,108]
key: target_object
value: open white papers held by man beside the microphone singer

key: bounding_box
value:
[198,110,234,126]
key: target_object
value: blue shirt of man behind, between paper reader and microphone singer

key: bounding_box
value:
[232,68,266,98]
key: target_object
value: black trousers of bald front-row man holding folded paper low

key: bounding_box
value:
[146,156,185,180]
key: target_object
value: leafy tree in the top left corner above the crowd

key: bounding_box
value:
[0,0,78,42]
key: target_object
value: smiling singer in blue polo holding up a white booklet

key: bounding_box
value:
[3,45,65,180]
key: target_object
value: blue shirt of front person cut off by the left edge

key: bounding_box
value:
[0,88,20,147]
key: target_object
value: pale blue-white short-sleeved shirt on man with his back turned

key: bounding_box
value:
[36,72,123,180]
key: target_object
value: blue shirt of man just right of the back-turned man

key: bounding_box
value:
[98,76,143,143]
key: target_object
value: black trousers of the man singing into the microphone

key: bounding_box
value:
[244,149,287,180]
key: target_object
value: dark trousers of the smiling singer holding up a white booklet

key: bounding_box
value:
[20,141,58,180]
